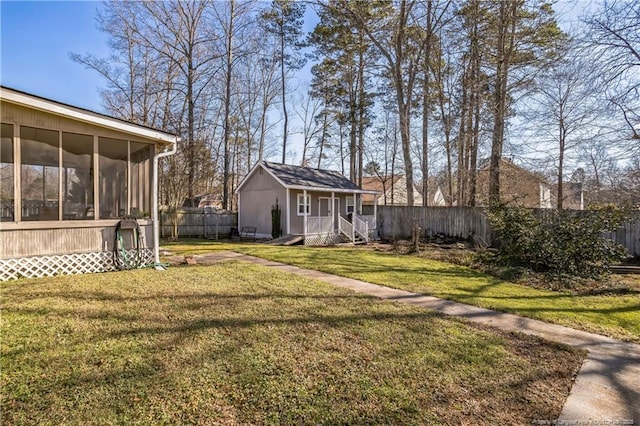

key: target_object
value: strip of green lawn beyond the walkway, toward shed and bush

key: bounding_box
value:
[166,242,640,342]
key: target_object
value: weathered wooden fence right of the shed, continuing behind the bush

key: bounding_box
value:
[377,206,640,257]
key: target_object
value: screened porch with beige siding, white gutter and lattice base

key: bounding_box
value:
[0,87,178,281]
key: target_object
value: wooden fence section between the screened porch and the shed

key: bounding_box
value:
[160,208,238,239]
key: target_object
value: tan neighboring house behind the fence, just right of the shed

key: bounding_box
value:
[362,174,422,206]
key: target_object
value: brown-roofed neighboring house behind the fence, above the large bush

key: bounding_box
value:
[476,159,554,209]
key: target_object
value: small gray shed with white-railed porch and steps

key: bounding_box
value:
[236,161,376,245]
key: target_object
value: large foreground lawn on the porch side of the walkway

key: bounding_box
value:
[0,262,584,425]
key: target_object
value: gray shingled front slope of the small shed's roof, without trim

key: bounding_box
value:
[263,161,361,191]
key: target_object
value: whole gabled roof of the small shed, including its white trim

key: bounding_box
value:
[238,161,377,194]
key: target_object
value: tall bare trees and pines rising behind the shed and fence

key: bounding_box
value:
[72,0,640,209]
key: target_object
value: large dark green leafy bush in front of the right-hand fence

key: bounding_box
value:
[488,205,629,278]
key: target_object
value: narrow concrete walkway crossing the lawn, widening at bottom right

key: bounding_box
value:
[188,252,640,425]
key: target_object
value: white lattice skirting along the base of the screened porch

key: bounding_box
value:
[0,248,153,281]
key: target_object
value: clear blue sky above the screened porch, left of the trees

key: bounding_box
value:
[0,0,108,111]
